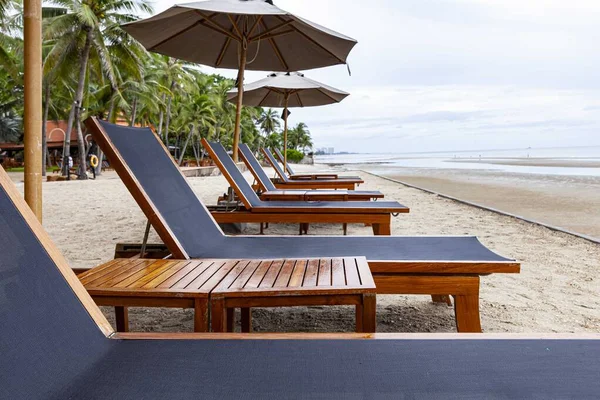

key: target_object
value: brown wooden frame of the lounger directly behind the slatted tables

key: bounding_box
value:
[86,118,521,332]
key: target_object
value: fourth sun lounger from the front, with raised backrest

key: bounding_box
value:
[239,143,384,201]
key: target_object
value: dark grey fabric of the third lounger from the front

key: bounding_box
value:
[208,142,404,209]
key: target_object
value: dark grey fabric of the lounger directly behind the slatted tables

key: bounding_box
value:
[100,121,509,261]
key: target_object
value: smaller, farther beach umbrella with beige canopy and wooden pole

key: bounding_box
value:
[227,72,349,167]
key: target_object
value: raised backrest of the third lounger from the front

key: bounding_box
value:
[202,139,262,208]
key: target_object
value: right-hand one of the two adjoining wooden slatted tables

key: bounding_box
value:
[210,257,376,332]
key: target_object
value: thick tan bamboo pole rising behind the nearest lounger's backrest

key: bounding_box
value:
[23,0,45,222]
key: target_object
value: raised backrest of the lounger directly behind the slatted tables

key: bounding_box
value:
[86,118,224,258]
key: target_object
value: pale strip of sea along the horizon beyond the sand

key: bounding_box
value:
[315,146,600,177]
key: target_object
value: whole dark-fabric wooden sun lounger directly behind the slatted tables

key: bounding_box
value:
[86,115,520,332]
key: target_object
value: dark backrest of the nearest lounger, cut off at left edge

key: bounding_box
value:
[0,167,112,399]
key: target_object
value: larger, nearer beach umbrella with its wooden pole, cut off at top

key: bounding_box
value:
[123,0,356,161]
